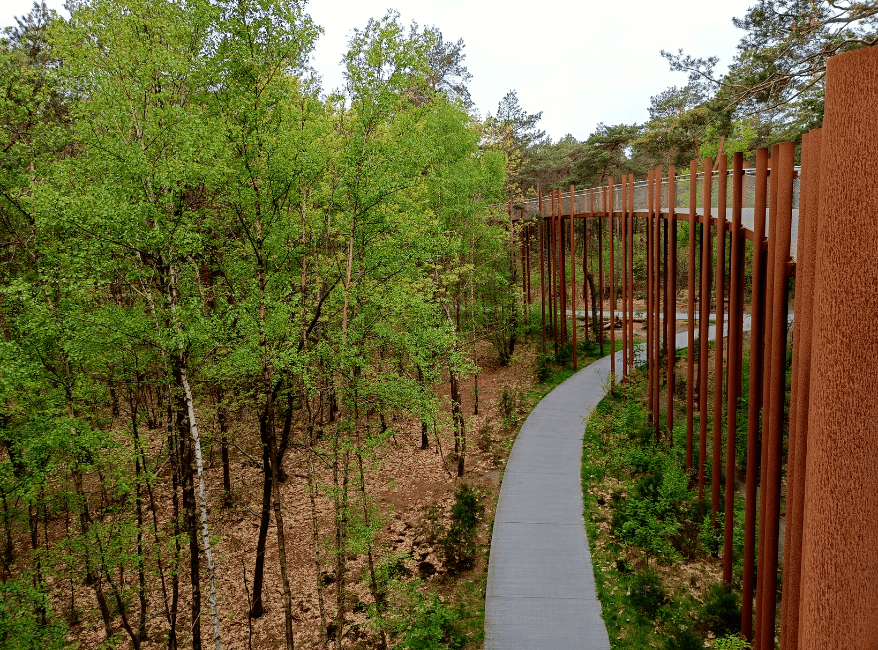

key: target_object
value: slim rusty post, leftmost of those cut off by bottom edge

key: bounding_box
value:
[754,145,780,647]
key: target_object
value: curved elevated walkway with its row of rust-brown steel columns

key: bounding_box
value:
[512,47,878,650]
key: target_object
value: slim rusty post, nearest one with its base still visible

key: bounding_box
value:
[741,148,768,640]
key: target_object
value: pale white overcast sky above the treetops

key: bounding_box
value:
[0,0,755,140]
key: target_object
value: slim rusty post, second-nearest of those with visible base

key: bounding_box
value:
[723,152,744,583]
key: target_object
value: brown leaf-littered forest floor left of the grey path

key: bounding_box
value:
[62,316,609,650]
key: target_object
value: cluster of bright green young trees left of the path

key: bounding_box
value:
[0,0,518,648]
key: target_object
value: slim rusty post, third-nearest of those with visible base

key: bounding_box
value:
[710,154,734,524]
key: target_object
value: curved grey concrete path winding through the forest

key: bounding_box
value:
[484,314,768,650]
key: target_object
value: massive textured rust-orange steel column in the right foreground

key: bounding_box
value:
[797,47,878,650]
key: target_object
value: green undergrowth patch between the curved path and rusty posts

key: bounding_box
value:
[582,375,749,650]
